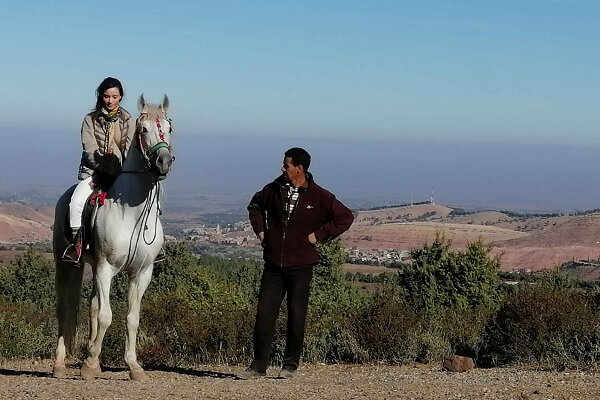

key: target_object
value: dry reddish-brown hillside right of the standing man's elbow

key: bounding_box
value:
[343,204,600,270]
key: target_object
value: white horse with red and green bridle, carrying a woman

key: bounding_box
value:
[53,95,174,380]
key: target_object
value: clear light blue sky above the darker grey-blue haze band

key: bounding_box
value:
[0,0,600,144]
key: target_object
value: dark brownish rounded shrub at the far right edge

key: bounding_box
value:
[486,285,600,369]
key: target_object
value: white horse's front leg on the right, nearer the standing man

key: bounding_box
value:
[125,264,154,381]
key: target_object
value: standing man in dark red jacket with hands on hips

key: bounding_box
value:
[240,147,354,379]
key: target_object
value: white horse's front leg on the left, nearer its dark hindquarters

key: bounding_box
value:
[81,260,113,379]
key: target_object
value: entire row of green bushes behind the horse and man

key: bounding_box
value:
[0,237,600,369]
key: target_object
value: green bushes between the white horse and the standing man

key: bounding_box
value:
[139,243,255,365]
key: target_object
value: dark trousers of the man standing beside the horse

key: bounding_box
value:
[250,263,313,372]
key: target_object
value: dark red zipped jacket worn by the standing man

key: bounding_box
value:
[248,173,354,267]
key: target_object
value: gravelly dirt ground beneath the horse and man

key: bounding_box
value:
[0,360,600,400]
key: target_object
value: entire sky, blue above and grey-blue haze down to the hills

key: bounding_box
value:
[0,0,600,210]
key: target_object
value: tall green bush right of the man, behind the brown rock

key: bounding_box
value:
[386,234,503,362]
